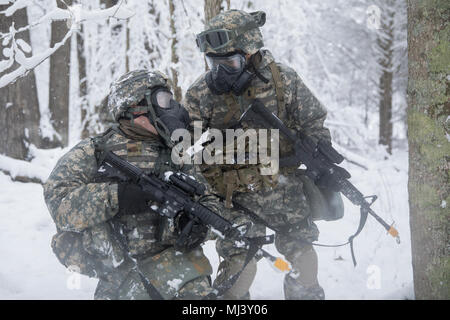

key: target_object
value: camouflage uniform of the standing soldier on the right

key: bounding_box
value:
[185,10,330,299]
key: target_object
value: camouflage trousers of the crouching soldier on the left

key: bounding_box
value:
[94,248,213,300]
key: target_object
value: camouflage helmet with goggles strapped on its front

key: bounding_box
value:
[197,10,266,54]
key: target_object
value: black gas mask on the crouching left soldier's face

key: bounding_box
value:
[124,86,190,147]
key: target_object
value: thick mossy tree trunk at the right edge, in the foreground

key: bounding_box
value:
[408,0,450,299]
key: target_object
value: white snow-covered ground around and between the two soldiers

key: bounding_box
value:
[0,144,414,299]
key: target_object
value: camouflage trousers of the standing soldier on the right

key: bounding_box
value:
[215,173,324,300]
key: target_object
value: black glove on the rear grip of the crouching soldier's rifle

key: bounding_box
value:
[118,182,150,215]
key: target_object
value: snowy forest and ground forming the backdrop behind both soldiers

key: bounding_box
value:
[0,0,445,299]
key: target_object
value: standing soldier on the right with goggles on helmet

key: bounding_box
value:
[185,10,342,299]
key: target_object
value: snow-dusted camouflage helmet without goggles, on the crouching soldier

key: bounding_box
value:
[108,69,170,121]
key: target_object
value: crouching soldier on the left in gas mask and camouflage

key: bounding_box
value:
[44,70,223,299]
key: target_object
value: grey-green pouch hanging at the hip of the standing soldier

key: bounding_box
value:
[299,175,344,221]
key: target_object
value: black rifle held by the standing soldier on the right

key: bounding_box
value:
[239,99,400,265]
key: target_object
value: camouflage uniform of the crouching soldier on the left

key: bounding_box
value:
[44,73,230,299]
